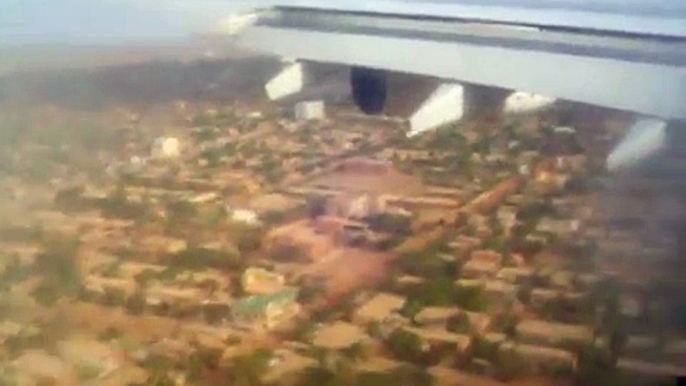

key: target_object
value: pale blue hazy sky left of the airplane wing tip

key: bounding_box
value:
[0,0,269,46]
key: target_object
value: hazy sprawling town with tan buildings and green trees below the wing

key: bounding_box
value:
[0,52,686,386]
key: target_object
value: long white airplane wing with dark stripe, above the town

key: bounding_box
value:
[239,0,686,120]
